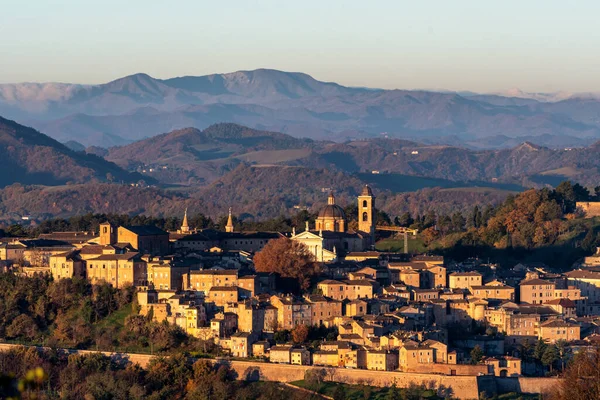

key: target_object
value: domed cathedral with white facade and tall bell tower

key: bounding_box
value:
[291,185,375,262]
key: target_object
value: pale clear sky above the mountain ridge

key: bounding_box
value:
[0,0,600,91]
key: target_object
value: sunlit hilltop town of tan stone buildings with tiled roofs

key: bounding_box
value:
[0,186,600,394]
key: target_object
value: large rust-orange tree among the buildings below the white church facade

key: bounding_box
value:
[254,237,321,289]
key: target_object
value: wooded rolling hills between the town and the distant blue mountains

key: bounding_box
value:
[106,124,600,192]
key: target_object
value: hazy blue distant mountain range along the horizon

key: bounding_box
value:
[0,69,600,148]
